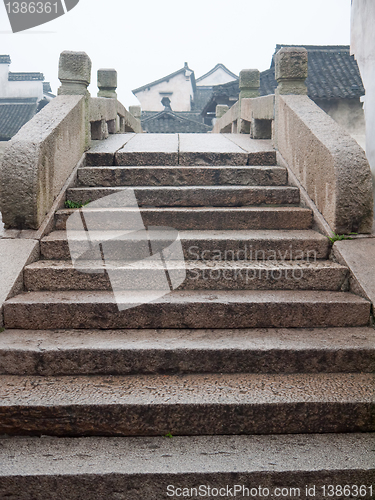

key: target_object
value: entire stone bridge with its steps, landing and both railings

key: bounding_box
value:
[0,48,375,500]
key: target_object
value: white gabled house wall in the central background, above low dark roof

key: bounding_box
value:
[135,72,194,111]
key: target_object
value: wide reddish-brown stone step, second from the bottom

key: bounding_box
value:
[0,373,375,436]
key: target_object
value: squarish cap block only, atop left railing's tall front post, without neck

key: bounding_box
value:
[59,50,91,86]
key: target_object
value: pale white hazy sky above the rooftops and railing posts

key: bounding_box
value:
[0,0,351,106]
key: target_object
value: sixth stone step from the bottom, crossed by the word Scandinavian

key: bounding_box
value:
[40,230,330,262]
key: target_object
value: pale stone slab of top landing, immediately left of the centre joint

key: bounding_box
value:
[115,134,179,166]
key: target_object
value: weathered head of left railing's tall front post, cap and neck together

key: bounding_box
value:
[58,50,91,96]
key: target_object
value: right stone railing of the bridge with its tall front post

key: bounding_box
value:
[213,47,373,234]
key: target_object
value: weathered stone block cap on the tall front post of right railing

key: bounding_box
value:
[275,47,308,81]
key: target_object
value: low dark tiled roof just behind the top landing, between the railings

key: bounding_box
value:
[141,109,211,134]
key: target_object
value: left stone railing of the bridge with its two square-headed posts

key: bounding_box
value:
[0,52,142,230]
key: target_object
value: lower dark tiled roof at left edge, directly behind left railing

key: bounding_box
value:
[0,98,37,141]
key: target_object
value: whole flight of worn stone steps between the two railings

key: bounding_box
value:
[0,138,375,500]
